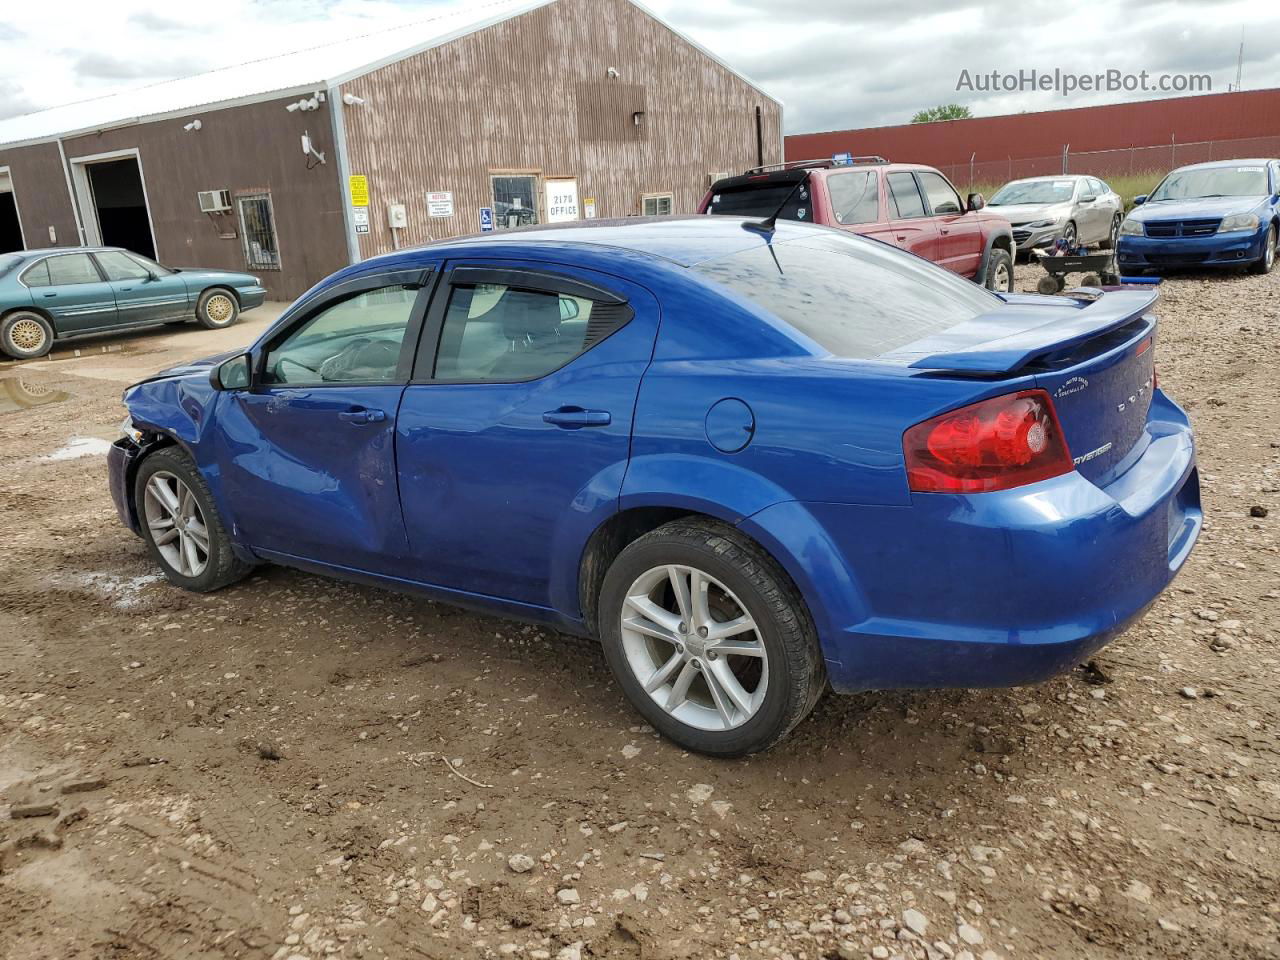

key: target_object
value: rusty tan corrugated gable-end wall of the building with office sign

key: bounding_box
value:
[343,0,782,256]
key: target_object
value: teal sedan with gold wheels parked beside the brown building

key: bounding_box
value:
[0,247,266,360]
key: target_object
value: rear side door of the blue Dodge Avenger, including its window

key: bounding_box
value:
[396,260,658,613]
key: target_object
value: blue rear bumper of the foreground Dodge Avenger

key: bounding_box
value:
[744,392,1202,692]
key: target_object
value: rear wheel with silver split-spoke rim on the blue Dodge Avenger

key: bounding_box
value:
[599,520,827,756]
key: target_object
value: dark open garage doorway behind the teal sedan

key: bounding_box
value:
[72,150,156,260]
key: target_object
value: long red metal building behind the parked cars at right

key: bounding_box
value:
[786,88,1280,183]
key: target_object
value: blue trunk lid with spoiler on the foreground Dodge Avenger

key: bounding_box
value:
[901,291,1158,485]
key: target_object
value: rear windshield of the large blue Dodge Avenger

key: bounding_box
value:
[692,232,1002,360]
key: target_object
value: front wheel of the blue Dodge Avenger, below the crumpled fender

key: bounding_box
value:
[133,447,252,594]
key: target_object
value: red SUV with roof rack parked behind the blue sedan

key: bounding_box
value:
[698,156,1014,293]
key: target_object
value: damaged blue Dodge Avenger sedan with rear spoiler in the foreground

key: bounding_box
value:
[110,218,1201,756]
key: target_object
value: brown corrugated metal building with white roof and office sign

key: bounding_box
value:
[0,0,782,298]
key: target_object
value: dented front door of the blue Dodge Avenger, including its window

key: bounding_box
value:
[214,270,434,573]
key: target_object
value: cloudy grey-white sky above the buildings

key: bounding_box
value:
[0,0,1280,133]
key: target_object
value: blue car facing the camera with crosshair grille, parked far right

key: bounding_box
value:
[1116,160,1280,274]
